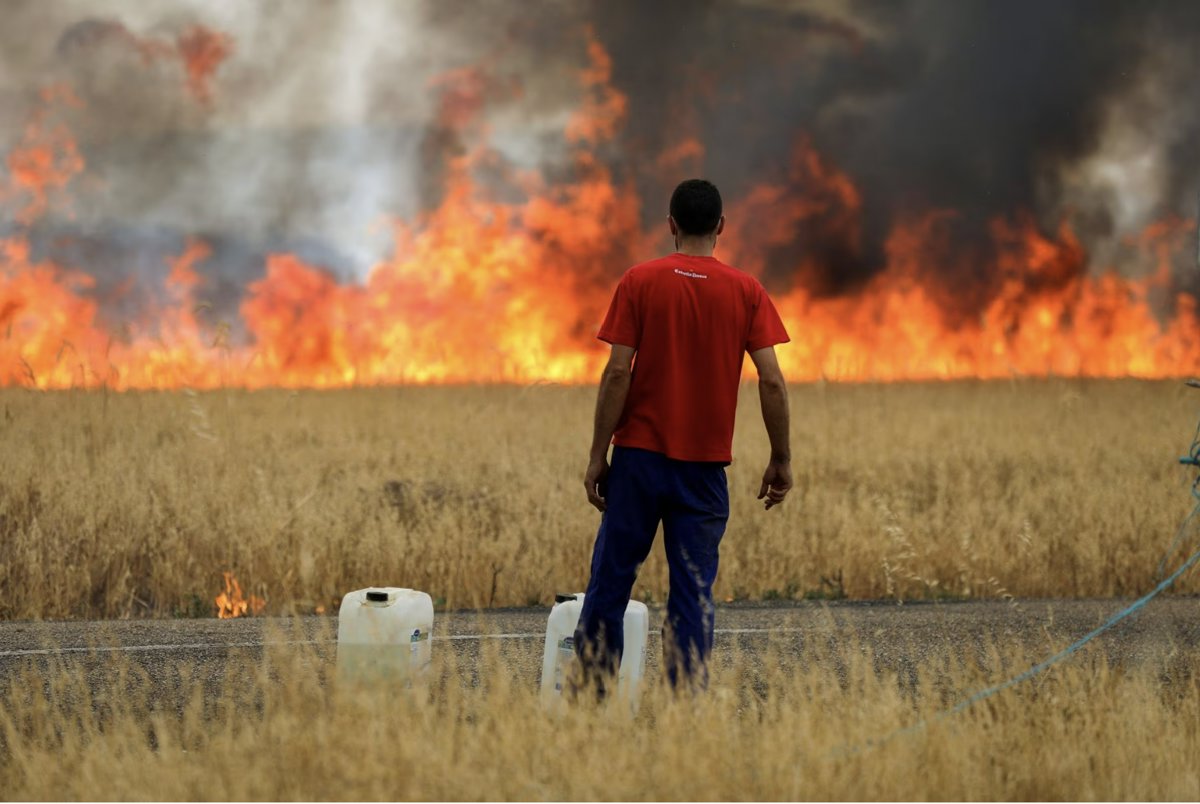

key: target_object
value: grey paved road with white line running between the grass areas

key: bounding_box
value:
[0,598,1200,688]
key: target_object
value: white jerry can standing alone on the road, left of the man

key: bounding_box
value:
[337,587,433,682]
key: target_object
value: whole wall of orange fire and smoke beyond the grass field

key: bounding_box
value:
[0,1,1200,390]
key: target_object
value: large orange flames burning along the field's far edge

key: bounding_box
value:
[0,31,1200,389]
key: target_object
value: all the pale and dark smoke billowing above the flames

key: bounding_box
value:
[0,0,1200,326]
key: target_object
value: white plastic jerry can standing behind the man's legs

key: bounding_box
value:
[541,594,650,710]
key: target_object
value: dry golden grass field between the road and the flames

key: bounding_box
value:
[0,379,1200,619]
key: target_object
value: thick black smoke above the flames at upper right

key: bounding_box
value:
[592,0,1200,301]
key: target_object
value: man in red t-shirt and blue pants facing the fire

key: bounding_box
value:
[575,179,792,696]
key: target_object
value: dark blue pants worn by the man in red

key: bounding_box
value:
[575,446,730,686]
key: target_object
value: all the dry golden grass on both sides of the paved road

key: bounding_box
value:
[0,380,1200,800]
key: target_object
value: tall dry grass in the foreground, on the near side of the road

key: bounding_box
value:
[0,635,1200,800]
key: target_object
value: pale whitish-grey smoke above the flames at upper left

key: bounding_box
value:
[0,0,595,276]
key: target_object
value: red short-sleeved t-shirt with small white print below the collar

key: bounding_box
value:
[598,253,788,463]
